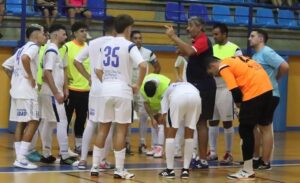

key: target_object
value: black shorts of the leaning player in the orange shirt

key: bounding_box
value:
[239,91,279,126]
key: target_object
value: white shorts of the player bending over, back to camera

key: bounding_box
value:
[167,94,202,130]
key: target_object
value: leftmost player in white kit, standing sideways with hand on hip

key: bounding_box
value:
[3,24,46,169]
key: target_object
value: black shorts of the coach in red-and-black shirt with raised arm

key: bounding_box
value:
[191,78,217,121]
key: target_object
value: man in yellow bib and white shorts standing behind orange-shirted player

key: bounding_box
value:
[207,23,243,164]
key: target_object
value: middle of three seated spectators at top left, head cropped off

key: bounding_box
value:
[37,0,58,28]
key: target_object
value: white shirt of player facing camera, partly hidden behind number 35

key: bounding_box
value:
[132,47,158,84]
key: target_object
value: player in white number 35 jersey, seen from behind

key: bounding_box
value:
[91,15,146,179]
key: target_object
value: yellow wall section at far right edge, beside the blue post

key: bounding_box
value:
[287,57,300,127]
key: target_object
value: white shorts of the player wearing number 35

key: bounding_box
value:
[99,97,132,124]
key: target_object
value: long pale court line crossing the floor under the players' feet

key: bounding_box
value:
[0,164,300,174]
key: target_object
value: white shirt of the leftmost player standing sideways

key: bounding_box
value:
[4,42,40,99]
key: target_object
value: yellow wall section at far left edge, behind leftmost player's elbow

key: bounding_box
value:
[0,47,12,128]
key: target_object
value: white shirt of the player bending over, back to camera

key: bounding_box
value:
[160,82,199,114]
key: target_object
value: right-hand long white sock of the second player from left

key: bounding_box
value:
[57,121,70,159]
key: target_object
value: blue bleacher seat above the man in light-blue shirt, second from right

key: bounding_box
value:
[254,8,278,27]
